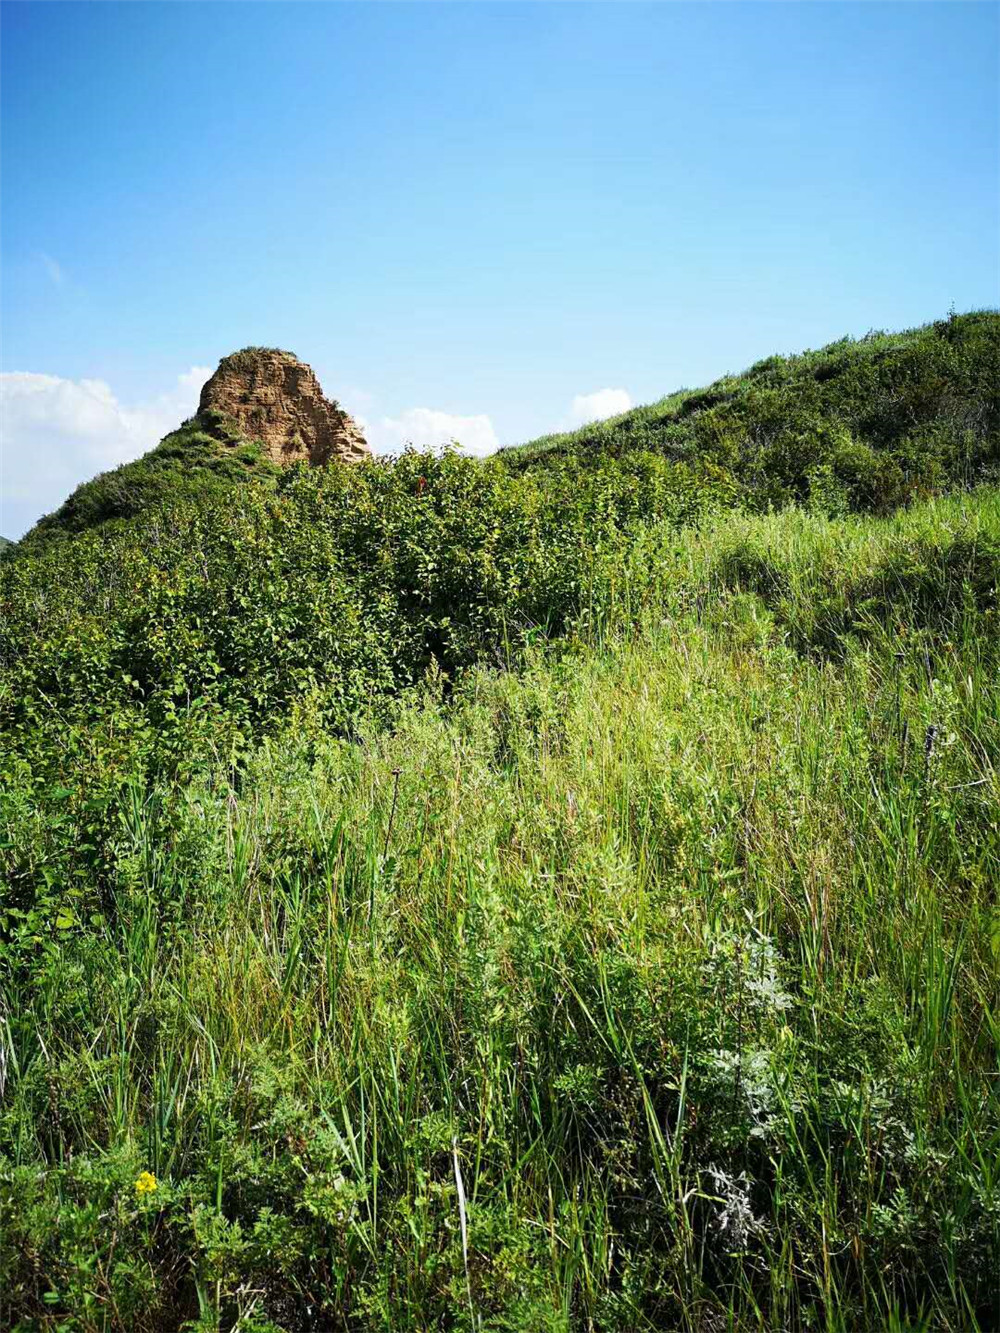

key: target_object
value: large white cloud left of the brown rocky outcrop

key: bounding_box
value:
[0,365,212,539]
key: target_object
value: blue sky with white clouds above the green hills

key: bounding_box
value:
[0,3,1000,536]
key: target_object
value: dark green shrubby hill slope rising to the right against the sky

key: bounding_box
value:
[501,311,1000,508]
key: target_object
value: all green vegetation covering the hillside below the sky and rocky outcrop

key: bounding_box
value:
[0,315,1000,1333]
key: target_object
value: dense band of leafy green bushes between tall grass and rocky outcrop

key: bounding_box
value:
[0,455,719,783]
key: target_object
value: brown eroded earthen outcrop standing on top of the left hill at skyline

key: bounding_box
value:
[199,347,371,465]
